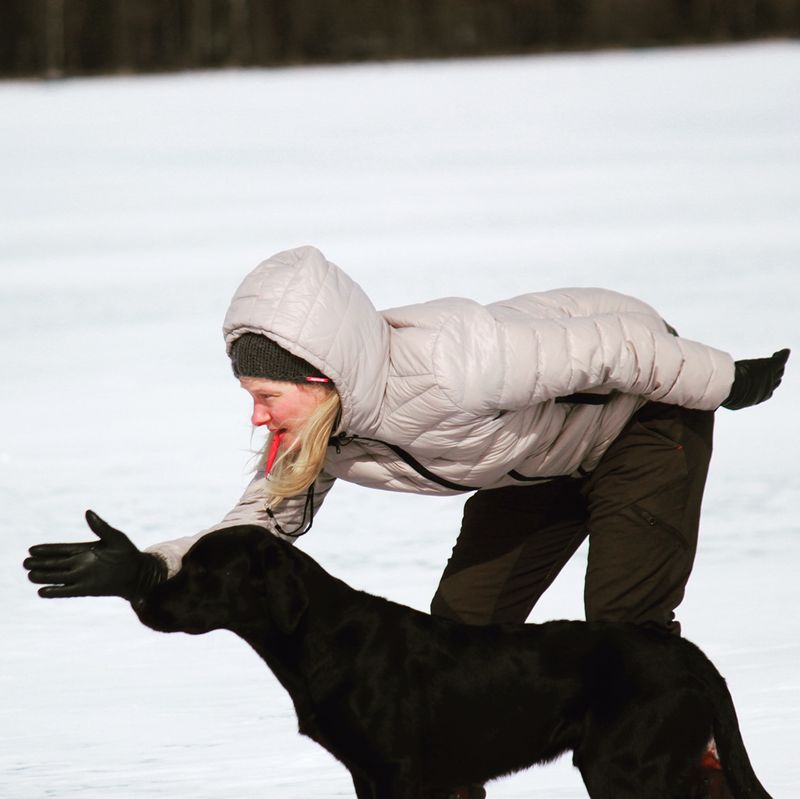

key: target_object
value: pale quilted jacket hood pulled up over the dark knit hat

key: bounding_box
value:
[223,247,389,435]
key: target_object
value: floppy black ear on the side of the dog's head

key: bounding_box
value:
[258,536,308,633]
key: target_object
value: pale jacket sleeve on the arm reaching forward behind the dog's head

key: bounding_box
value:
[146,471,335,577]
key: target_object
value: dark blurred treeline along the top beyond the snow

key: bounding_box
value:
[0,0,800,77]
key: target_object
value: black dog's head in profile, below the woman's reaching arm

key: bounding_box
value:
[134,525,308,635]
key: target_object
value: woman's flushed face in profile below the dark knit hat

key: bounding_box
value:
[239,377,329,446]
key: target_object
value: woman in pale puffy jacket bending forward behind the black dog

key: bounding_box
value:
[26,247,789,796]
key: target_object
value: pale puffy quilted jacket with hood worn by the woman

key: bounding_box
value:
[150,247,733,573]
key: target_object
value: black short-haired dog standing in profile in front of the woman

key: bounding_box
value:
[134,526,769,799]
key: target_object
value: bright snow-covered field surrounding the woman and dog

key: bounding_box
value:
[0,43,800,799]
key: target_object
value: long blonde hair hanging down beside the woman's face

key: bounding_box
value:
[258,385,341,508]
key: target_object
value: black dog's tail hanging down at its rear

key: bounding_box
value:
[703,656,772,799]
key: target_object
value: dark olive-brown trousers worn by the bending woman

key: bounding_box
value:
[431,403,714,634]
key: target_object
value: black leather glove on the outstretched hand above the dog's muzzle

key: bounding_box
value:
[22,510,167,600]
